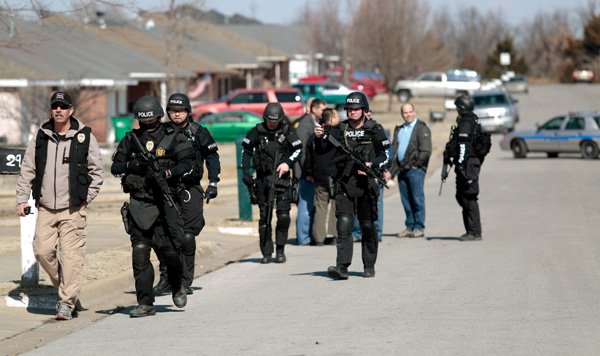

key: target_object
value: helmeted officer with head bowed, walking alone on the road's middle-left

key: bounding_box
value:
[242,103,302,264]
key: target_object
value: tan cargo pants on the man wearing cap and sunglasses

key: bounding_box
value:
[33,205,87,309]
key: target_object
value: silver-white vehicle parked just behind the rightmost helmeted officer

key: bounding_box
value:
[473,89,519,132]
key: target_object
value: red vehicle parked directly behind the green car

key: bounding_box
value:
[194,88,304,120]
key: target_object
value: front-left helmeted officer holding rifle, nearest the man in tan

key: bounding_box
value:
[111,96,194,318]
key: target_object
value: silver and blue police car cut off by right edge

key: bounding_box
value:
[500,111,600,159]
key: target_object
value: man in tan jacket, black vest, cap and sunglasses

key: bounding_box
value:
[17,92,104,320]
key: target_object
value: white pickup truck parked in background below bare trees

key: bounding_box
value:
[394,69,481,102]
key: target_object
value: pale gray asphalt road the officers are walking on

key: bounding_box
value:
[21,85,600,355]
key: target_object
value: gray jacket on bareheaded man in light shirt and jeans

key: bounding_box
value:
[390,119,431,177]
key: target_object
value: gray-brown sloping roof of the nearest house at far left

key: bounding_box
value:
[0,16,195,85]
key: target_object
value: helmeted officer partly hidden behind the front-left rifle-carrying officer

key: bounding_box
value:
[154,93,221,294]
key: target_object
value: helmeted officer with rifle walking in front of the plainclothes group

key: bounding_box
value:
[315,92,390,280]
